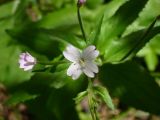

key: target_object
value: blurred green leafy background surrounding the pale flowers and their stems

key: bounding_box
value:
[0,0,160,120]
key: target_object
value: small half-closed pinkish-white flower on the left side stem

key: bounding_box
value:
[19,52,36,71]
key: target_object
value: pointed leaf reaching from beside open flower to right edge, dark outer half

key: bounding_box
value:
[104,19,160,62]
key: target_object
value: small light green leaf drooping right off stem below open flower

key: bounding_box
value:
[93,86,114,110]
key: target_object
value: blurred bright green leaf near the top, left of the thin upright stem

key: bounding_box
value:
[37,6,78,30]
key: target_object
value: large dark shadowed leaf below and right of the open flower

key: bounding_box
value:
[99,61,160,114]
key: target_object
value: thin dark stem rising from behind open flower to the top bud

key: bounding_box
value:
[77,5,87,43]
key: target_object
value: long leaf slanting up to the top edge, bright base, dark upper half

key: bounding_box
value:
[98,0,148,54]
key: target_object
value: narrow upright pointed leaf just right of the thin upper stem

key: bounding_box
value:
[88,14,104,45]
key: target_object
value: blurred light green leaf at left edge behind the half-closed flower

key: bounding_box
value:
[0,46,33,87]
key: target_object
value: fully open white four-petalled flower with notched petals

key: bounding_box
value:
[63,45,99,80]
